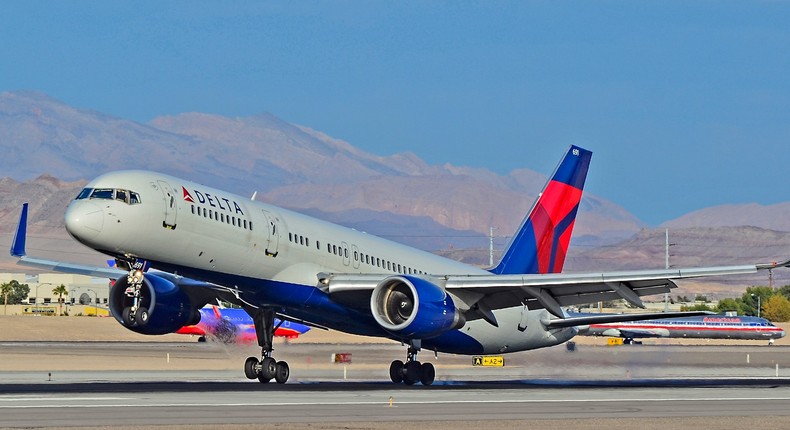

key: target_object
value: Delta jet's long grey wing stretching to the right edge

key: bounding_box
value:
[318,260,790,325]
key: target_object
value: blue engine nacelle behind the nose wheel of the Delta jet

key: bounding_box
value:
[110,274,200,335]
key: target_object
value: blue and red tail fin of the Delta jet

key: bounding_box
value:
[490,146,592,275]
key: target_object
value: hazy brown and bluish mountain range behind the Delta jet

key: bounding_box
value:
[0,91,790,292]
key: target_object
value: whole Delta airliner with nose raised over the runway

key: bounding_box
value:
[11,145,790,385]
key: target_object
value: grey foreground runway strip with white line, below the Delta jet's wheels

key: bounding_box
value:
[0,383,790,427]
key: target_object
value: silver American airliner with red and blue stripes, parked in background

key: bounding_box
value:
[575,314,785,344]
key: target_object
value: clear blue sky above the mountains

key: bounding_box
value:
[0,1,790,225]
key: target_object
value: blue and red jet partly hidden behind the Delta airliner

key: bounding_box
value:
[176,305,310,343]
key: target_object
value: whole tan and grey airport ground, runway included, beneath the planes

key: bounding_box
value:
[0,316,790,430]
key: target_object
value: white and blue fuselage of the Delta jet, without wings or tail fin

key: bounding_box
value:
[66,171,576,353]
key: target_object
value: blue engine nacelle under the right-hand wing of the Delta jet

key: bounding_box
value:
[370,276,466,339]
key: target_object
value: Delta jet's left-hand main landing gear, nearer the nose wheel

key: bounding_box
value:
[244,309,291,384]
